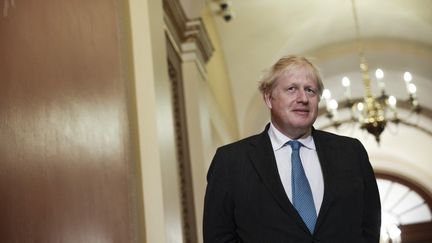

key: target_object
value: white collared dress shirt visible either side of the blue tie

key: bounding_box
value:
[268,123,324,214]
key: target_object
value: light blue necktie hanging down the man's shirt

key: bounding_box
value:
[288,140,317,233]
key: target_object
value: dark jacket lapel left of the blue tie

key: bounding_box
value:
[249,125,309,232]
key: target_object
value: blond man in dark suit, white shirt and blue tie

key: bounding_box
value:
[203,56,381,243]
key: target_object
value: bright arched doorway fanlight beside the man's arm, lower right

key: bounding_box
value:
[376,172,432,243]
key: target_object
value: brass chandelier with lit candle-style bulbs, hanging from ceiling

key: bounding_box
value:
[323,0,420,144]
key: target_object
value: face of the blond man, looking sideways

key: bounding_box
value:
[265,71,320,139]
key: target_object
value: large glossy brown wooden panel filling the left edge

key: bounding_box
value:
[0,0,135,243]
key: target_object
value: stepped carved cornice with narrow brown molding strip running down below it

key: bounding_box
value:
[163,0,214,243]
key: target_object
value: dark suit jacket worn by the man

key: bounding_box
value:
[203,125,381,243]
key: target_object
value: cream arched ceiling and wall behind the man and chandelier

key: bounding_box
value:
[208,0,432,188]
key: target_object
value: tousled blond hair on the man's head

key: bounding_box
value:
[258,55,324,97]
